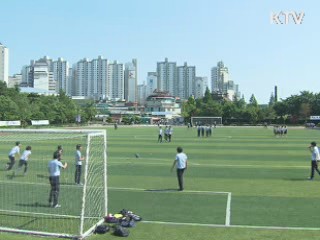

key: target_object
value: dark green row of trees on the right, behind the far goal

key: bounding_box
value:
[182,89,320,124]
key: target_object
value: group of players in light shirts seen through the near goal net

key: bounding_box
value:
[6,141,85,208]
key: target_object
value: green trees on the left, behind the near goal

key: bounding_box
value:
[0,81,96,125]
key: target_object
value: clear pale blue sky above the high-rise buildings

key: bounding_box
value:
[0,0,320,104]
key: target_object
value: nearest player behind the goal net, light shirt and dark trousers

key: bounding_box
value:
[48,152,68,208]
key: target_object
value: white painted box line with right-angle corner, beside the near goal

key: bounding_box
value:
[108,187,231,226]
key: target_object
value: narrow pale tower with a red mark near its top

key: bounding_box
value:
[124,59,138,102]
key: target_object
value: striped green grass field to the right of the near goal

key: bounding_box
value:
[0,127,320,240]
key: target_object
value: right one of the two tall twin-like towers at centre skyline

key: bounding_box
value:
[174,62,196,99]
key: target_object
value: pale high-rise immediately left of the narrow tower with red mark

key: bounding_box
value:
[107,61,124,100]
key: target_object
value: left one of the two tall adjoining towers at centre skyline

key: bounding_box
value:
[157,58,177,95]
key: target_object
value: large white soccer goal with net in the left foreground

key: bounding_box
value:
[0,129,108,239]
